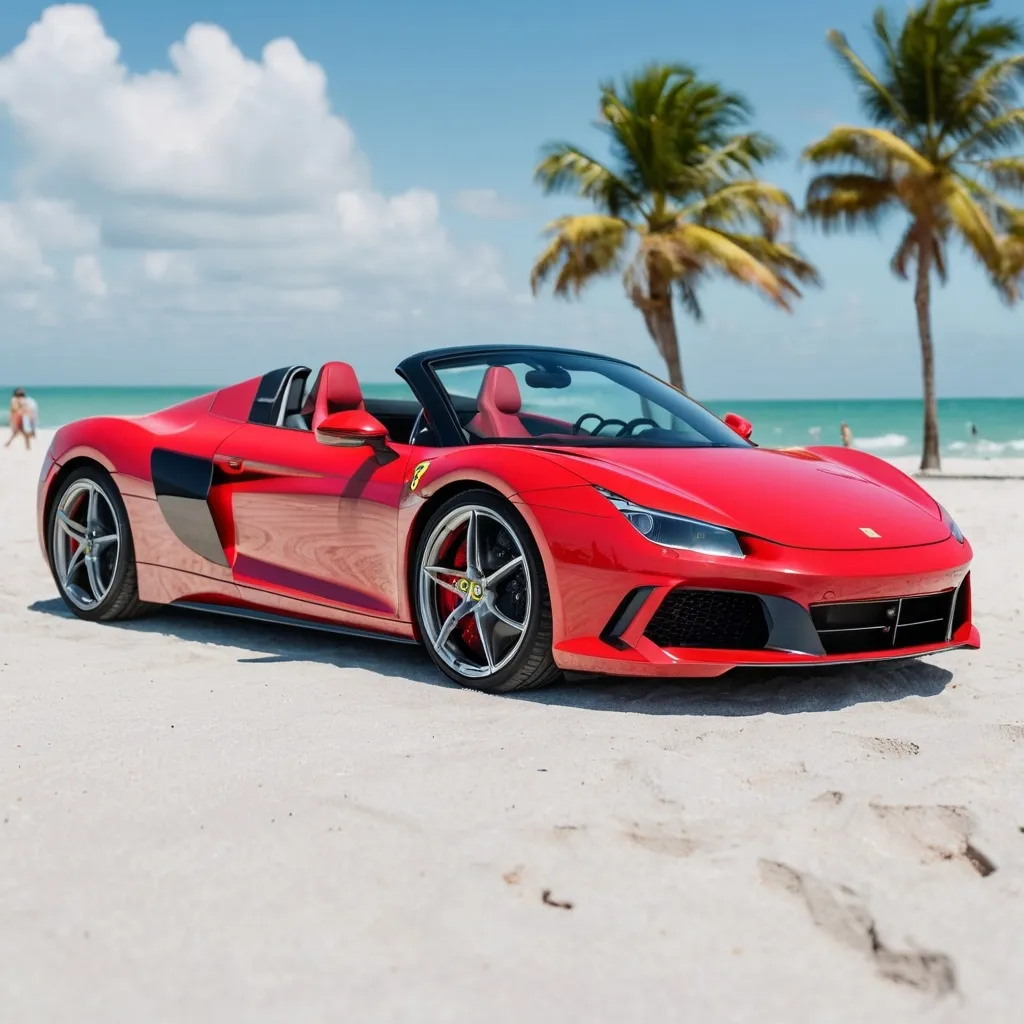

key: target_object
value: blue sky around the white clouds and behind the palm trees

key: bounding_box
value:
[0,0,1024,397]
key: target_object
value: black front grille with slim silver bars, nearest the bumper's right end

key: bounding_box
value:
[811,588,963,654]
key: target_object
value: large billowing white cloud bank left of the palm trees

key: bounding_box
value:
[0,4,509,323]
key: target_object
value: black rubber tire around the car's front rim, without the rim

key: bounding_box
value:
[411,489,561,693]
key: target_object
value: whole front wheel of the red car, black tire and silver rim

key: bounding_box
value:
[415,490,558,693]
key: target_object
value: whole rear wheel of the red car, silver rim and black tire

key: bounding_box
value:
[47,466,148,622]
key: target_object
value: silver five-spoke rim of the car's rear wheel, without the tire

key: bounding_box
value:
[51,479,121,611]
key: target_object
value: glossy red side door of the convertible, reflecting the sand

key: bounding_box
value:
[211,423,412,618]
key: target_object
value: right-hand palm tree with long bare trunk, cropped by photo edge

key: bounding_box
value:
[804,0,1024,470]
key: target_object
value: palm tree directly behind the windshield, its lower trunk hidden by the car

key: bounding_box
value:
[530,65,816,390]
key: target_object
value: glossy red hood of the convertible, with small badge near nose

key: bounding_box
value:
[549,447,949,551]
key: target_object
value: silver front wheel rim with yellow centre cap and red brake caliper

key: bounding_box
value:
[419,505,532,679]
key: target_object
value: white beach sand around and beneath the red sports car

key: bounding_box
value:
[6,428,1024,1024]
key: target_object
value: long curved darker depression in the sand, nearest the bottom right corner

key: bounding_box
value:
[760,860,956,996]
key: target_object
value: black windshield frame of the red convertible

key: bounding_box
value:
[395,345,757,451]
